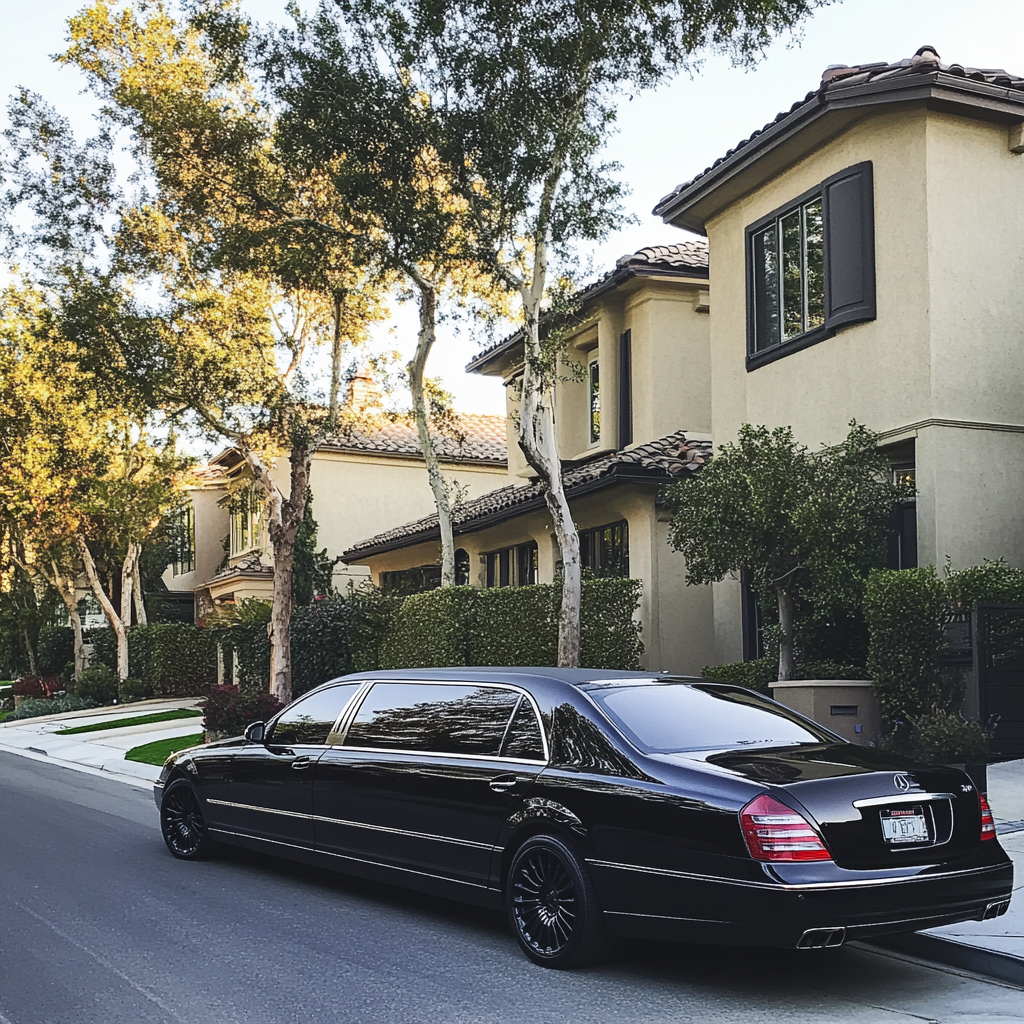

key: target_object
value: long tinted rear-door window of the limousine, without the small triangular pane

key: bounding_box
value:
[345,683,519,757]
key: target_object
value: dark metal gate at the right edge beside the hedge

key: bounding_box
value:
[977,604,1024,756]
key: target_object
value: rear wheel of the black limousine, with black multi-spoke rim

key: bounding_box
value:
[505,836,612,970]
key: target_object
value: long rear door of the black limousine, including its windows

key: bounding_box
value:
[313,681,545,886]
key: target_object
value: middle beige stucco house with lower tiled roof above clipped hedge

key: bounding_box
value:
[343,240,714,672]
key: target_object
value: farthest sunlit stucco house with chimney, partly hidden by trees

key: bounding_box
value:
[164,376,507,617]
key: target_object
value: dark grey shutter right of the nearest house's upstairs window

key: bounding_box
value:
[821,162,876,328]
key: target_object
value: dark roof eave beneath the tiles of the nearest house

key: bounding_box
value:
[653,72,1024,234]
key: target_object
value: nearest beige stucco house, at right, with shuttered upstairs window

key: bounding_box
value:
[655,46,1024,662]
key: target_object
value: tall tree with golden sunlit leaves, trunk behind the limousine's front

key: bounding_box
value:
[61,3,385,702]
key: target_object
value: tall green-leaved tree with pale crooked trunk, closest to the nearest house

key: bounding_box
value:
[339,0,818,666]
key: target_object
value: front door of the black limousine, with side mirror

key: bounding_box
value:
[229,683,361,847]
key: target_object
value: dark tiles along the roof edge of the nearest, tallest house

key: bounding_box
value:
[653,46,1024,215]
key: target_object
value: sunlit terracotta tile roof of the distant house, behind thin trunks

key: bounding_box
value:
[321,413,508,465]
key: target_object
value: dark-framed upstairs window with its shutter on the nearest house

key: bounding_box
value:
[746,162,877,370]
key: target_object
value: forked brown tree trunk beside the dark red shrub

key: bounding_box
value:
[246,430,315,705]
